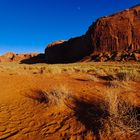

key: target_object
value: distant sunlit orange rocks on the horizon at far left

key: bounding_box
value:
[0,52,39,62]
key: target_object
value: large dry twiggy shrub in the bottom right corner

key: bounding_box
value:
[103,92,140,136]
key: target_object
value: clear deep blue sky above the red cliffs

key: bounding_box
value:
[0,0,140,54]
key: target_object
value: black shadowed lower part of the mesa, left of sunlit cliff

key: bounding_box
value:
[45,36,93,63]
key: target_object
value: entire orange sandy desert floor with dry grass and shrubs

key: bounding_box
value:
[0,62,140,140]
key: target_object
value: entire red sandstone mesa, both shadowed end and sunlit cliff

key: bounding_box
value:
[45,5,140,63]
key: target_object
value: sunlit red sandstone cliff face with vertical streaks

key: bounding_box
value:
[87,6,140,52]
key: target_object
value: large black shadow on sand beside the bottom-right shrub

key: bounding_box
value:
[67,98,109,140]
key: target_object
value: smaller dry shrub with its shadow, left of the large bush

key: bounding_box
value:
[26,85,71,107]
